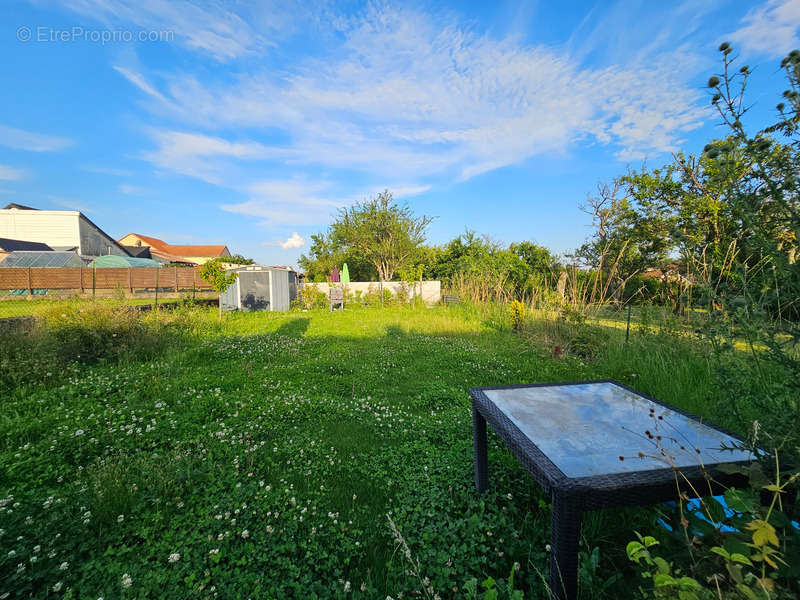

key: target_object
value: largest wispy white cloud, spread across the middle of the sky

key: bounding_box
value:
[126,5,709,185]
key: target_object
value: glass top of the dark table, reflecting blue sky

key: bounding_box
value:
[483,382,751,477]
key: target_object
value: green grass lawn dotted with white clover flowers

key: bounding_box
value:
[0,307,732,600]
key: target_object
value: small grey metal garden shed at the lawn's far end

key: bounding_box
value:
[220,265,297,311]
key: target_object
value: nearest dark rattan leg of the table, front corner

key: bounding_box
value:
[550,494,581,600]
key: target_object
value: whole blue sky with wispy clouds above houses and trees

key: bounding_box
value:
[0,0,800,264]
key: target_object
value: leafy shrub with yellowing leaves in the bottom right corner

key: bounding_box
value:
[627,457,800,600]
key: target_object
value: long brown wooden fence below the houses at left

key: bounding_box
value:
[0,267,211,294]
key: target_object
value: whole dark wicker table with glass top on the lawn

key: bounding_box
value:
[470,380,751,600]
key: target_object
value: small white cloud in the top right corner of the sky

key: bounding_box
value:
[729,0,800,57]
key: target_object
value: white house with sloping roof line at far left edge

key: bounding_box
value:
[0,203,130,256]
